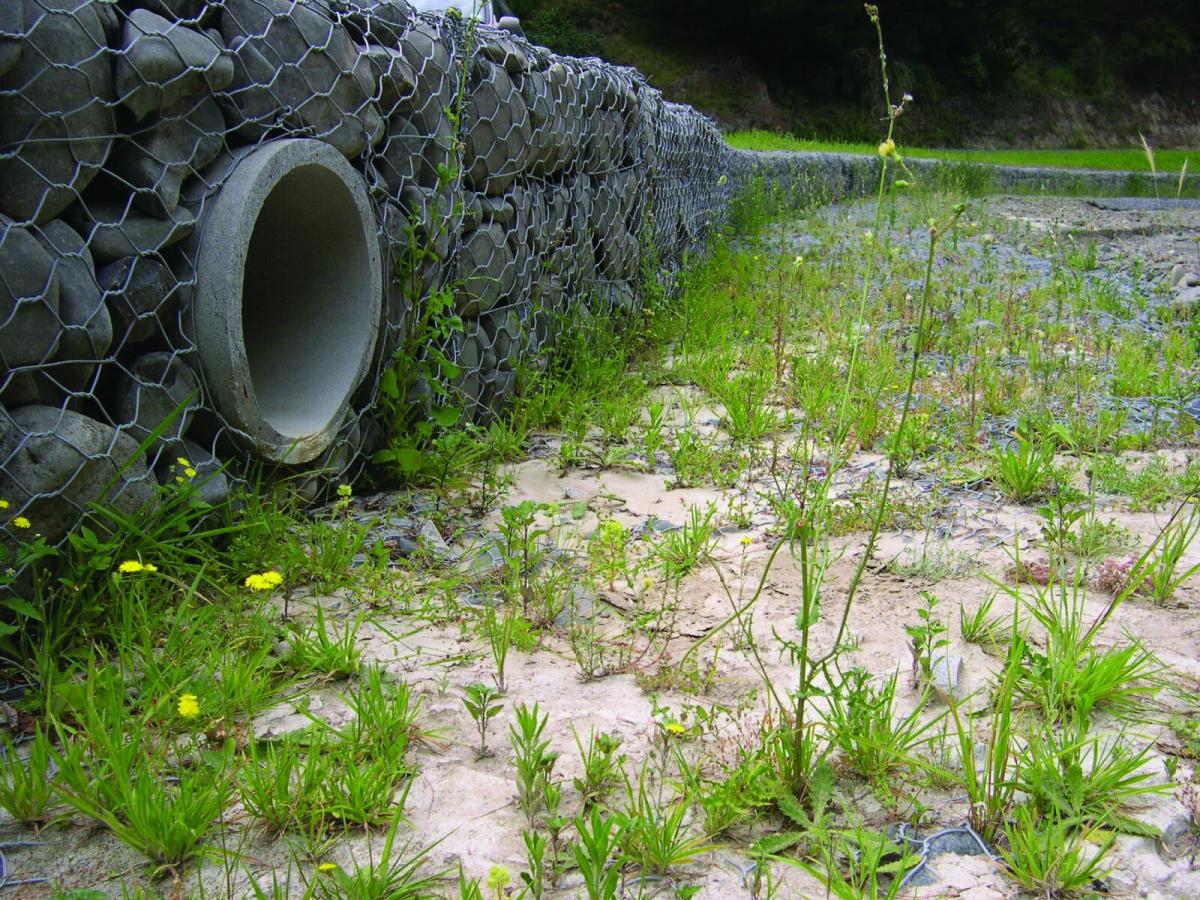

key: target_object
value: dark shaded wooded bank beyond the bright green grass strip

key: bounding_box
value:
[510,0,1200,148]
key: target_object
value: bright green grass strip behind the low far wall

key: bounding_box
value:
[725,131,1200,174]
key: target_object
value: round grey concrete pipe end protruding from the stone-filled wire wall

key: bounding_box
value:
[193,139,383,463]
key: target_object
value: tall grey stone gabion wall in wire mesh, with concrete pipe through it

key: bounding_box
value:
[0,0,733,554]
